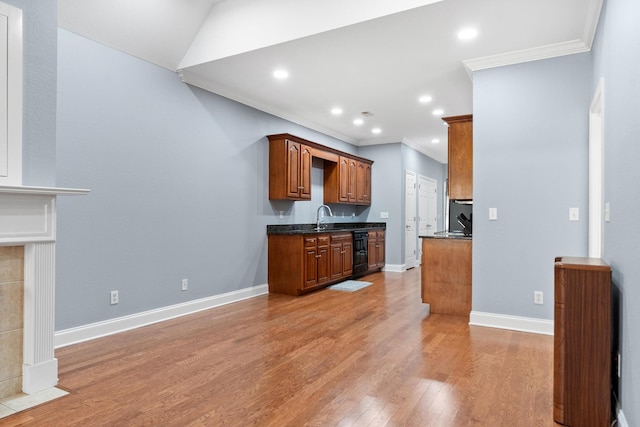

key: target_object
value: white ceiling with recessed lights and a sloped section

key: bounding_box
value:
[58,0,602,163]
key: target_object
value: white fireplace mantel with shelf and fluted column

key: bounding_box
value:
[0,186,89,394]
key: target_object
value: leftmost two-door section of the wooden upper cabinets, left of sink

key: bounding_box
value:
[269,138,312,200]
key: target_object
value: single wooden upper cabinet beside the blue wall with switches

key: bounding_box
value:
[442,114,473,200]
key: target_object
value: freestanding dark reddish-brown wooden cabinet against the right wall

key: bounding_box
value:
[553,257,612,427]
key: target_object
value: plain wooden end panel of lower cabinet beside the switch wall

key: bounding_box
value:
[421,238,471,317]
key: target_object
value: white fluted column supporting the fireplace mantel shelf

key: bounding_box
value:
[22,242,58,394]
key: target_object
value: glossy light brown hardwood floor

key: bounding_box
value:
[0,268,555,426]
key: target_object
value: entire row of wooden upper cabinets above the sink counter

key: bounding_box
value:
[268,134,373,205]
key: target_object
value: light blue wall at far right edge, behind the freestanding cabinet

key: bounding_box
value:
[590,0,640,426]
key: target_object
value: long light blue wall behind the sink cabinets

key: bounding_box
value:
[56,30,439,330]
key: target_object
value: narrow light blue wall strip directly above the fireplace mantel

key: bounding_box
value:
[3,0,58,186]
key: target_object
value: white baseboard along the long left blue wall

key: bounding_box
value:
[54,284,269,348]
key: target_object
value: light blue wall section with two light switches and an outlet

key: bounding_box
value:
[472,54,591,319]
